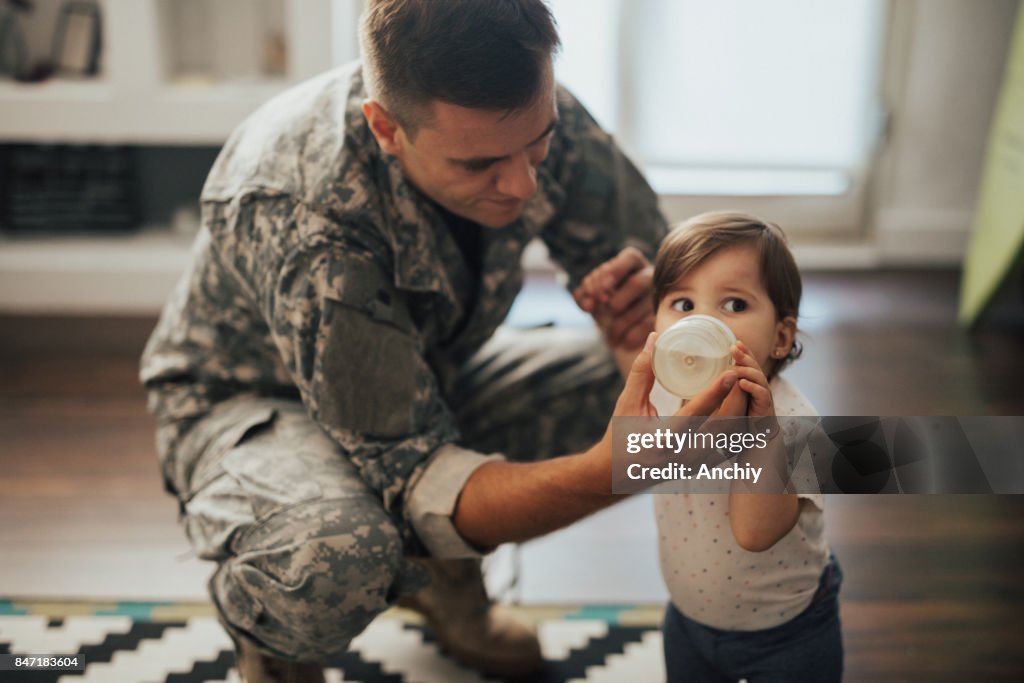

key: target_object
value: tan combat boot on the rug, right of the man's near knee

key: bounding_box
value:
[398,559,544,678]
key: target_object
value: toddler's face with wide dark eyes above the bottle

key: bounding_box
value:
[654,245,797,374]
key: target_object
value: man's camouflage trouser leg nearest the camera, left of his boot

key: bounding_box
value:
[182,396,413,660]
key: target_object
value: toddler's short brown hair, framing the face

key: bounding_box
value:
[653,211,803,375]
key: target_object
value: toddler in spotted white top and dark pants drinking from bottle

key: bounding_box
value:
[585,212,843,683]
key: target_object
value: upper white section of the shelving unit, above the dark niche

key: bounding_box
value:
[0,0,335,145]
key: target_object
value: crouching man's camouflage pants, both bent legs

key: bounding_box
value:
[173,328,622,660]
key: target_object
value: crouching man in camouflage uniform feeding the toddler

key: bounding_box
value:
[141,0,665,680]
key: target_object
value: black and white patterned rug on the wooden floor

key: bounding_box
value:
[0,599,665,683]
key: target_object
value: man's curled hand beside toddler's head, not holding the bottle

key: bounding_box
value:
[572,247,654,351]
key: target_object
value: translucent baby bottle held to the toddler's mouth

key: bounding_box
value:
[652,314,736,398]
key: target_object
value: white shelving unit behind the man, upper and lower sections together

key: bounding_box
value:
[0,0,352,314]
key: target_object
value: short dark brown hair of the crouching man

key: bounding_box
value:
[359,0,559,135]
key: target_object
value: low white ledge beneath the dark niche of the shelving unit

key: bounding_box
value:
[0,230,190,314]
